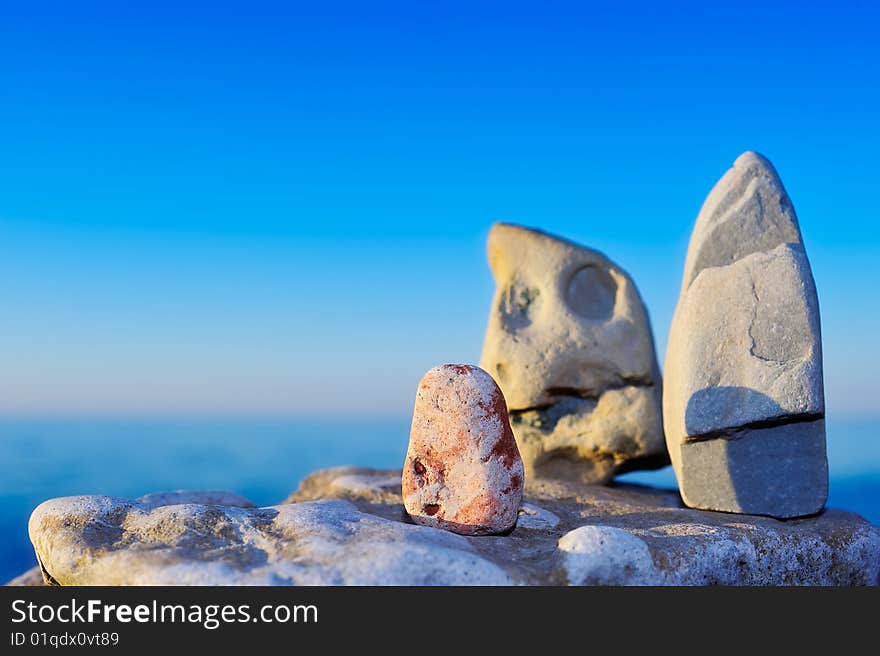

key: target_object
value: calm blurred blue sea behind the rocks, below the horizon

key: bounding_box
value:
[0,419,880,582]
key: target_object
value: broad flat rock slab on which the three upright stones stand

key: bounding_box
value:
[30,468,880,585]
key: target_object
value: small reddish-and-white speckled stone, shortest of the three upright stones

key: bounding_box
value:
[402,364,525,535]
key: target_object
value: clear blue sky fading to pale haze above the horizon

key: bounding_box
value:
[0,2,880,416]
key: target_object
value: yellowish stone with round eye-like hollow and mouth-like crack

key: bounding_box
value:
[480,224,668,483]
